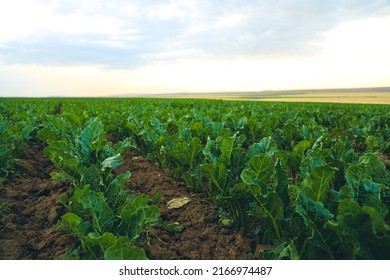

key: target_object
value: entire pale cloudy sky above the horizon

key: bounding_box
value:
[0,0,390,97]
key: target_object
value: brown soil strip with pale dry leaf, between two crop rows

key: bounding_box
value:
[116,151,259,260]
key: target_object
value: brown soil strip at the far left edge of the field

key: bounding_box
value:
[0,142,72,260]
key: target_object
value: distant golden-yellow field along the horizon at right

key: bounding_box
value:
[155,91,390,104]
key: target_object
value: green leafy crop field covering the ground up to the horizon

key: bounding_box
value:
[0,98,390,259]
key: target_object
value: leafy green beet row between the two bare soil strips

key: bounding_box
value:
[39,116,160,259]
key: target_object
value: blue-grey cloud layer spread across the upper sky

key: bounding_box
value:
[0,0,390,68]
